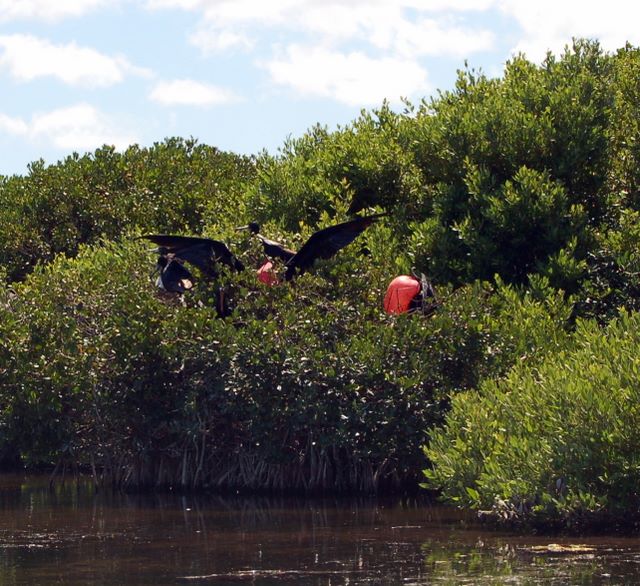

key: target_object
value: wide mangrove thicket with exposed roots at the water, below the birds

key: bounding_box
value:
[0,226,568,491]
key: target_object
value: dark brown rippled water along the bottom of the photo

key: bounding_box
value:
[0,476,640,586]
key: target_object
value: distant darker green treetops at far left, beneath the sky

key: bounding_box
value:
[0,139,255,280]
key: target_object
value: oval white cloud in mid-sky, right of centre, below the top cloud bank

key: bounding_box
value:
[265,46,428,106]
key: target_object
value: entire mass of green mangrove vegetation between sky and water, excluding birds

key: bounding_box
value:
[0,41,640,523]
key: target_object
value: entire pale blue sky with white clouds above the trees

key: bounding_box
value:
[0,0,640,175]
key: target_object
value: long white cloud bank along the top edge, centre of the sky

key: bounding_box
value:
[147,0,498,57]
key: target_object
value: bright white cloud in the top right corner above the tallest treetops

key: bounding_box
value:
[499,0,640,61]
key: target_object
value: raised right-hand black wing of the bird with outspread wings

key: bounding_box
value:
[284,213,387,281]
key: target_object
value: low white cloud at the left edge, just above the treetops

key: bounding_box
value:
[0,104,137,151]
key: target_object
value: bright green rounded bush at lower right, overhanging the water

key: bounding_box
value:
[426,313,640,526]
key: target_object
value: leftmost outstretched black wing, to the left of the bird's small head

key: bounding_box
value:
[140,234,244,278]
